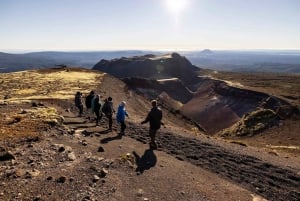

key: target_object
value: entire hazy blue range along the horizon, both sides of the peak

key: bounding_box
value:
[0,49,300,73]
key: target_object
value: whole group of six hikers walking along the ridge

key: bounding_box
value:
[75,91,163,149]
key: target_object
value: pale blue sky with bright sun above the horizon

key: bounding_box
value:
[0,0,300,51]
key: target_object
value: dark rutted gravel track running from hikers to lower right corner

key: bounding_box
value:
[61,107,300,201]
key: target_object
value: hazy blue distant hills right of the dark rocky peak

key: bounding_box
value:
[183,50,300,73]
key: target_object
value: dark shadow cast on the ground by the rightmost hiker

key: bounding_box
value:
[132,149,157,174]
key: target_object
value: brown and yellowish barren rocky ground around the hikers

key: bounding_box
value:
[0,69,300,201]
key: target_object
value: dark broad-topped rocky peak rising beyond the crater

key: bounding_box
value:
[93,53,199,83]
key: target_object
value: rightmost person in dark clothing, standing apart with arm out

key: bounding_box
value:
[141,100,163,149]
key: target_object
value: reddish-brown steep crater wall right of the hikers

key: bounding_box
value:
[181,78,289,134]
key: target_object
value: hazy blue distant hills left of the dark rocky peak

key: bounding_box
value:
[0,50,157,73]
